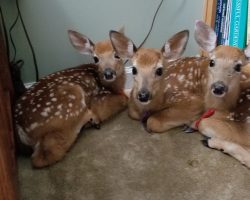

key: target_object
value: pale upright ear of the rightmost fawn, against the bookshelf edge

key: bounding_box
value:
[194,20,216,52]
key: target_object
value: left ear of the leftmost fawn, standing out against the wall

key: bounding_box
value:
[68,30,95,55]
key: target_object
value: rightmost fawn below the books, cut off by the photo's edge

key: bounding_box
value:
[195,21,250,167]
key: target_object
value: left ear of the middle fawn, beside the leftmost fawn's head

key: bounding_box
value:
[109,31,137,59]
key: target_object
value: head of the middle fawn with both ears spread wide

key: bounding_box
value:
[110,30,189,105]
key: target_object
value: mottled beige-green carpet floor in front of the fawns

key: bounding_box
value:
[18,112,250,200]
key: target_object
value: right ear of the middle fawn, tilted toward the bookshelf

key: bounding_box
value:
[161,30,189,60]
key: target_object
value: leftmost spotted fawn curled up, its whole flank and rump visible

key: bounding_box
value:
[14,30,128,167]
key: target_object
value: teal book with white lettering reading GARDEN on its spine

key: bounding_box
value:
[229,0,248,49]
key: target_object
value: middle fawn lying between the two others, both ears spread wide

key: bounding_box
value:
[110,30,213,133]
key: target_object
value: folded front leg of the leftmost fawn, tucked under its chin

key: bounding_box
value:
[91,94,128,122]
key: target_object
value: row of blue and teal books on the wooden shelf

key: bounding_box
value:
[214,0,250,48]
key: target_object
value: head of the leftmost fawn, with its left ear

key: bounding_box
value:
[68,30,124,83]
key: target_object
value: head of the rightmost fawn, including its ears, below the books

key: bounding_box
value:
[195,21,250,97]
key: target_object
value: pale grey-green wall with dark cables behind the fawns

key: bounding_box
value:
[0,0,203,82]
